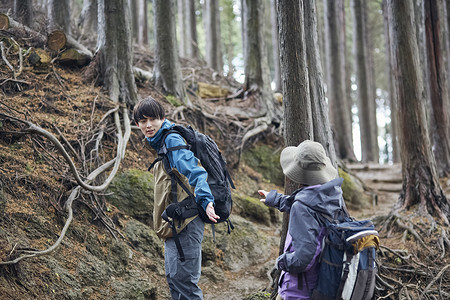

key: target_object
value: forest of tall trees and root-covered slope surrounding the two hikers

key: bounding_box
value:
[0,0,450,300]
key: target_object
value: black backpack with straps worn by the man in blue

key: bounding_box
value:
[148,125,235,257]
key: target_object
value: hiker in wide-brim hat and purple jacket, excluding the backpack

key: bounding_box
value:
[258,140,348,300]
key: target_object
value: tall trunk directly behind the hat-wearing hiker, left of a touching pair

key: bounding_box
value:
[271,0,313,299]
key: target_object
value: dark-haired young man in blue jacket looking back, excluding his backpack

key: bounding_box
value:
[133,97,219,300]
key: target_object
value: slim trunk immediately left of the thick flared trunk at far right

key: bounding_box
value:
[382,0,400,163]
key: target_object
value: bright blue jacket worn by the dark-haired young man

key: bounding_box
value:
[147,119,214,210]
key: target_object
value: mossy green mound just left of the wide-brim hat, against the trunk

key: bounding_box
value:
[243,143,284,186]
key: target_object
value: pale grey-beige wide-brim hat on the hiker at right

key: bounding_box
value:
[280,140,338,186]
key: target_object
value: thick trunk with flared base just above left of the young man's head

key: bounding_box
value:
[97,0,138,106]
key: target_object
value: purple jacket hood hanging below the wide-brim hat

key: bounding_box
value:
[295,178,344,219]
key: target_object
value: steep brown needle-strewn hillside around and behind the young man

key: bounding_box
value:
[0,36,281,299]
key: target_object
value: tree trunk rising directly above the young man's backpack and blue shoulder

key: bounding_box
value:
[153,0,190,104]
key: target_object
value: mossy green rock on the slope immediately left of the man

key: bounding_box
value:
[106,169,154,226]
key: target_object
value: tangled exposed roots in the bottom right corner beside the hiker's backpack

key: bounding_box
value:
[376,210,450,299]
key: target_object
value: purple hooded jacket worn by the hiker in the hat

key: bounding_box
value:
[265,178,345,300]
